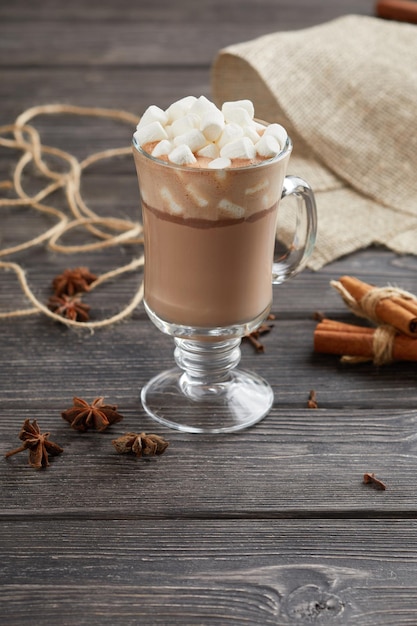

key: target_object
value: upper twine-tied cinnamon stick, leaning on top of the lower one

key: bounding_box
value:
[331,276,417,337]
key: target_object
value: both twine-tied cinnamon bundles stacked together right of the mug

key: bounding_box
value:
[314,276,417,365]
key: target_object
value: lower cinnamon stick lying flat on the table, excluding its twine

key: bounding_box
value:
[314,320,417,362]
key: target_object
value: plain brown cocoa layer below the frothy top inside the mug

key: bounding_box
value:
[143,200,276,328]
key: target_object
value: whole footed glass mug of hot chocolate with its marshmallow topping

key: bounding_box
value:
[133,96,316,433]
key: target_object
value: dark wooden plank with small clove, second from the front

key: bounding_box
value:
[0,402,417,520]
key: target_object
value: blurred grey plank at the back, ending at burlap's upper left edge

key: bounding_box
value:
[0,21,272,67]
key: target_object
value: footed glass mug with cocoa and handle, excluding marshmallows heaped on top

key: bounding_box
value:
[133,127,316,433]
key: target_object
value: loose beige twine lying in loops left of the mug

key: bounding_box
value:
[0,104,144,330]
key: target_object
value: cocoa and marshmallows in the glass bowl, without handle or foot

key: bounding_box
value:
[133,96,291,328]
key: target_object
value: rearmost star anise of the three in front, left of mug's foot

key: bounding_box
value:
[61,398,123,431]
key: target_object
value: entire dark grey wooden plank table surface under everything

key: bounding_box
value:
[0,0,417,626]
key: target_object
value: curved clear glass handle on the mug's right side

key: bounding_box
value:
[272,176,317,285]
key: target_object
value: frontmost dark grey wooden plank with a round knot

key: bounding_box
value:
[0,519,417,626]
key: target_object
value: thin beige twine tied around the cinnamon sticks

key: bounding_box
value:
[330,280,416,365]
